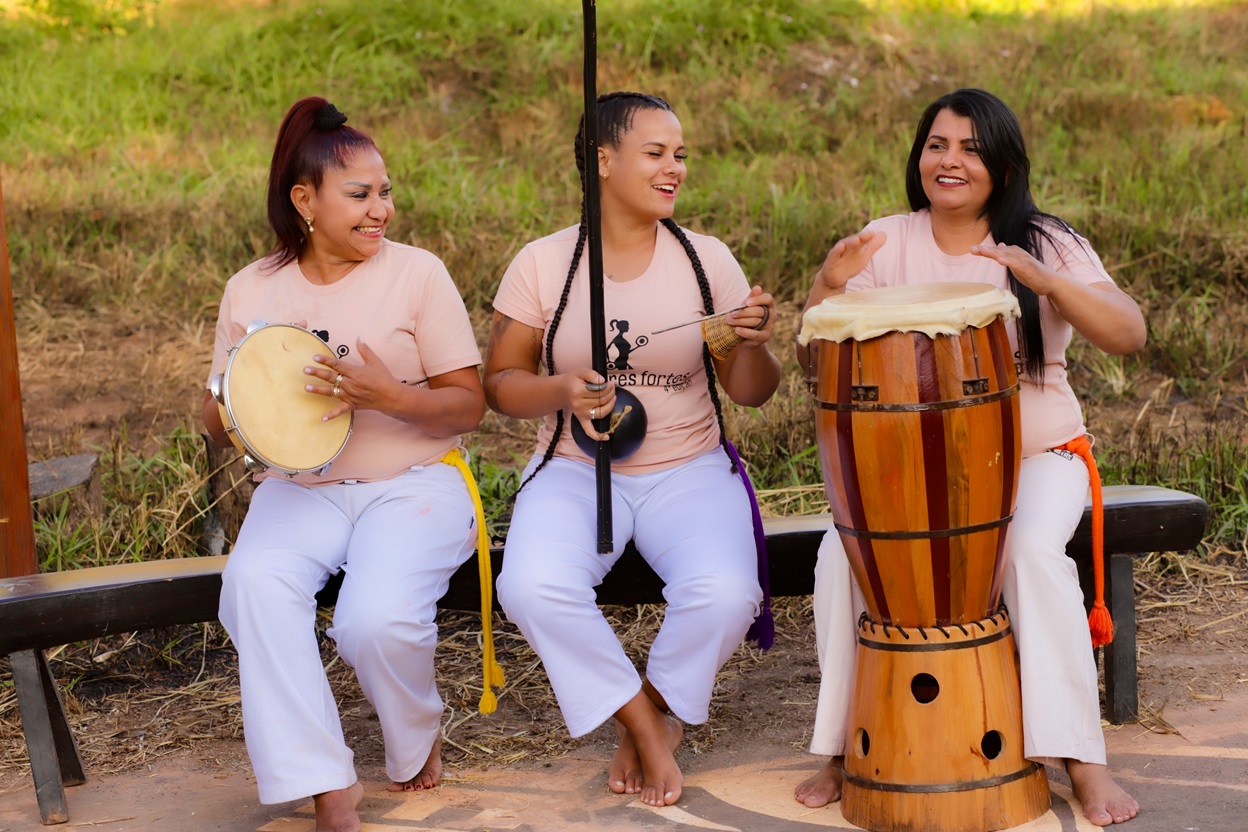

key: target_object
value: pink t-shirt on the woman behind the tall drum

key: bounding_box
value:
[846,211,1113,457]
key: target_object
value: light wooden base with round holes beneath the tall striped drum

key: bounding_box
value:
[842,612,1050,832]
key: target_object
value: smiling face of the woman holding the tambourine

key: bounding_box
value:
[291,148,394,262]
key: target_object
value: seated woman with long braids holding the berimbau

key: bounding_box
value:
[485,92,780,806]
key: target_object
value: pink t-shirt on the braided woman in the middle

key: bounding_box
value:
[494,226,750,474]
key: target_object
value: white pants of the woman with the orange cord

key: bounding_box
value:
[810,452,1106,766]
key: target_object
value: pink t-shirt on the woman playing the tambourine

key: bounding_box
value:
[212,241,480,485]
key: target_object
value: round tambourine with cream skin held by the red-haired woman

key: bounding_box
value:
[210,322,354,476]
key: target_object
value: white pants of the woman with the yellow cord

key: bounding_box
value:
[221,463,477,803]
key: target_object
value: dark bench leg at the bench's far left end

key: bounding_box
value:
[9,650,86,825]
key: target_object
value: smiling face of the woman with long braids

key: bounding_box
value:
[598,110,686,222]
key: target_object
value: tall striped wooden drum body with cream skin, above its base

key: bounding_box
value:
[800,283,1021,626]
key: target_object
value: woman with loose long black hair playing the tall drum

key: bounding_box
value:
[795,90,1146,826]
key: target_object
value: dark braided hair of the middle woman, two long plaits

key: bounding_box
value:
[517,92,736,491]
